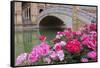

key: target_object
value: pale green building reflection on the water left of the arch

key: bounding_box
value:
[15,29,40,57]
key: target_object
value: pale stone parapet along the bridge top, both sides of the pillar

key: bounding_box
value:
[38,6,96,23]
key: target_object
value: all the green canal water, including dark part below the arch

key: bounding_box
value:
[15,28,63,59]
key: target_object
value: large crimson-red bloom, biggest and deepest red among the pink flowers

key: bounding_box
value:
[65,39,81,53]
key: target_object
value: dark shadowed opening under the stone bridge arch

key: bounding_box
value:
[39,15,65,28]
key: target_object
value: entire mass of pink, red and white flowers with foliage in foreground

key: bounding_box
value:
[16,23,97,65]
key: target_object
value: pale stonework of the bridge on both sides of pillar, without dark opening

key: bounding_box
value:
[37,7,96,27]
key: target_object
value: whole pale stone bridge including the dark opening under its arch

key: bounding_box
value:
[36,6,96,27]
